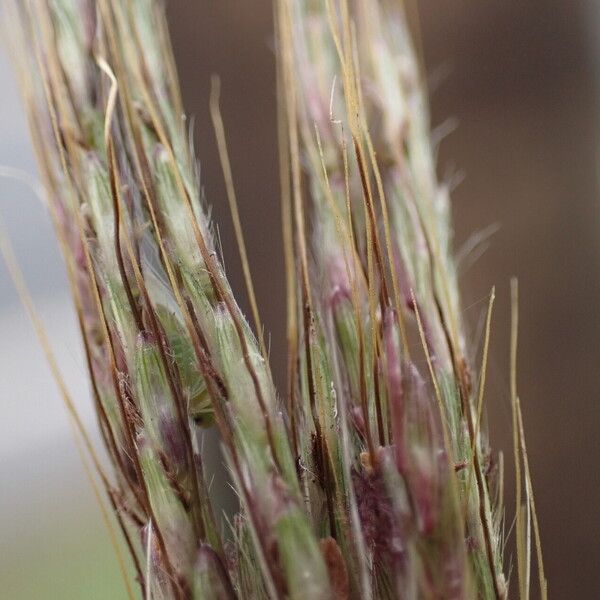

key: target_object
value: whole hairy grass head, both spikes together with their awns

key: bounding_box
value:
[4,0,545,600]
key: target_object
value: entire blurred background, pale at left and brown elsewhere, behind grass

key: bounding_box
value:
[0,0,600,600]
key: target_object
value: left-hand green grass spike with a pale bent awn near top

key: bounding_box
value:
[4,0,328,597]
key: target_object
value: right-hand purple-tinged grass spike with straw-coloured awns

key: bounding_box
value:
[280,2,505,596]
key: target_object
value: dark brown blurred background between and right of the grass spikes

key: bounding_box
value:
[169,0,600,599]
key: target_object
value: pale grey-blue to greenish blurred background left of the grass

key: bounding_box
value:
[0,53,126,600]
